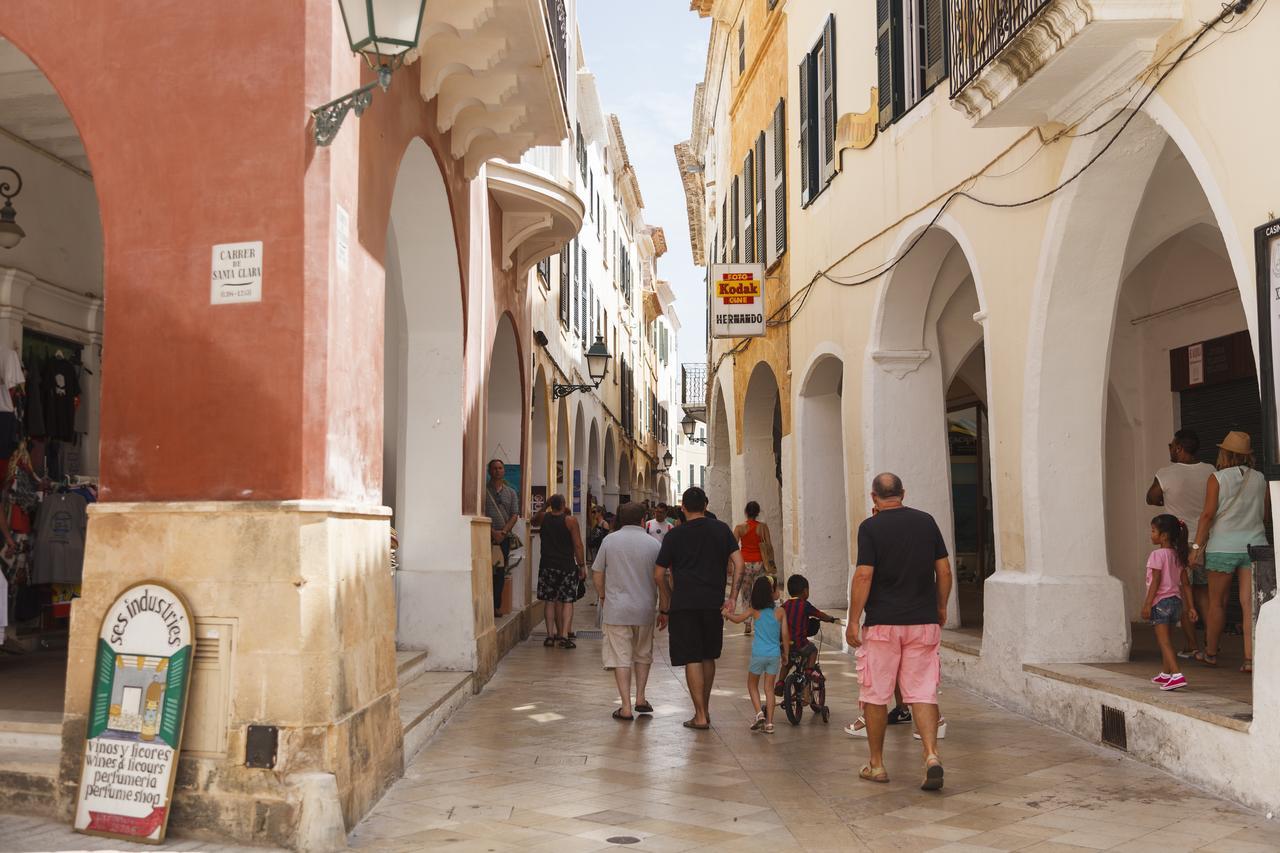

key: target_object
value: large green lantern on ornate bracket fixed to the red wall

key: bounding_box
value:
[311,0,426,147]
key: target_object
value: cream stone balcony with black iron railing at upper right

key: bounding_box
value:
[950,0,1183,127]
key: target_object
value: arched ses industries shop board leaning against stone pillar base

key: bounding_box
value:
[76,581,192,844]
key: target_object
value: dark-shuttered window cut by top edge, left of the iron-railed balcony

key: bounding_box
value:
[876,0,947,128]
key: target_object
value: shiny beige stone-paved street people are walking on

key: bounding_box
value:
[0,625,1280,853]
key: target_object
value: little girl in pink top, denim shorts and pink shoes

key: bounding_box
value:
[1142,514,1198,690]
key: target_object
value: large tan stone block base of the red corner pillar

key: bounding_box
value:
[59,501,403,847]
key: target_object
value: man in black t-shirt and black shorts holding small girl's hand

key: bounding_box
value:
[653,487,742,729]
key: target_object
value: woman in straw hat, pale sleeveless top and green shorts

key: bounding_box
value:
[1192,430,1271,672]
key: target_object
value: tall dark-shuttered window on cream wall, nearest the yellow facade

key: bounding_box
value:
[800,15,839,205]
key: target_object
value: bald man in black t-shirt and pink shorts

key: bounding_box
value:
[845,474,951,790]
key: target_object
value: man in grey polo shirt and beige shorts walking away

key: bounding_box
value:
[591,503,659,720]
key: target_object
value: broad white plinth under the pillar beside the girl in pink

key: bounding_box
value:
[982,571,1132,663]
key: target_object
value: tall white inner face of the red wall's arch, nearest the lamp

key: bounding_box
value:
[383,138,476,653]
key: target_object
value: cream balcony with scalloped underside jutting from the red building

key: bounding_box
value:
[411,0,570,178]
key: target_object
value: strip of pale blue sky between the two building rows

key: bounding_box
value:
[577,0,710,362]
